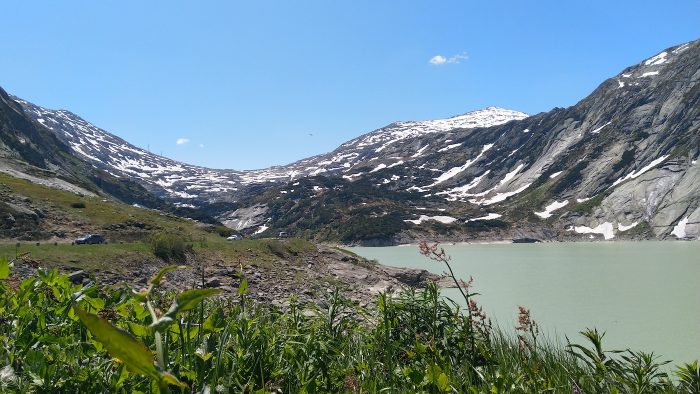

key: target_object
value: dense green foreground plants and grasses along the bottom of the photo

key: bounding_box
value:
[0,245,700,393]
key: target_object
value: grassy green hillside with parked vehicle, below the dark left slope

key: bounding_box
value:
[0,173,313,270]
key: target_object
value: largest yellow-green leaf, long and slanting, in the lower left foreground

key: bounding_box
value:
[73,305,161,380]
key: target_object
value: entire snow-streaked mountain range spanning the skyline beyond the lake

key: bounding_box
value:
[6,41,700,244]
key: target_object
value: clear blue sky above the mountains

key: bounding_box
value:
[0,0,700,169]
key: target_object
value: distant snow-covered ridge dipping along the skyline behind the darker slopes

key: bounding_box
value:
[14,97,527,205]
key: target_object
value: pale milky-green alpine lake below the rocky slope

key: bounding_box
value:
[348,241,700,365]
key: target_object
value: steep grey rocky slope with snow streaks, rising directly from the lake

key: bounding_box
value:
[228,41,700,243]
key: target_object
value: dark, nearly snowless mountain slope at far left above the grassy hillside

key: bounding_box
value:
[0,88,226,239]
